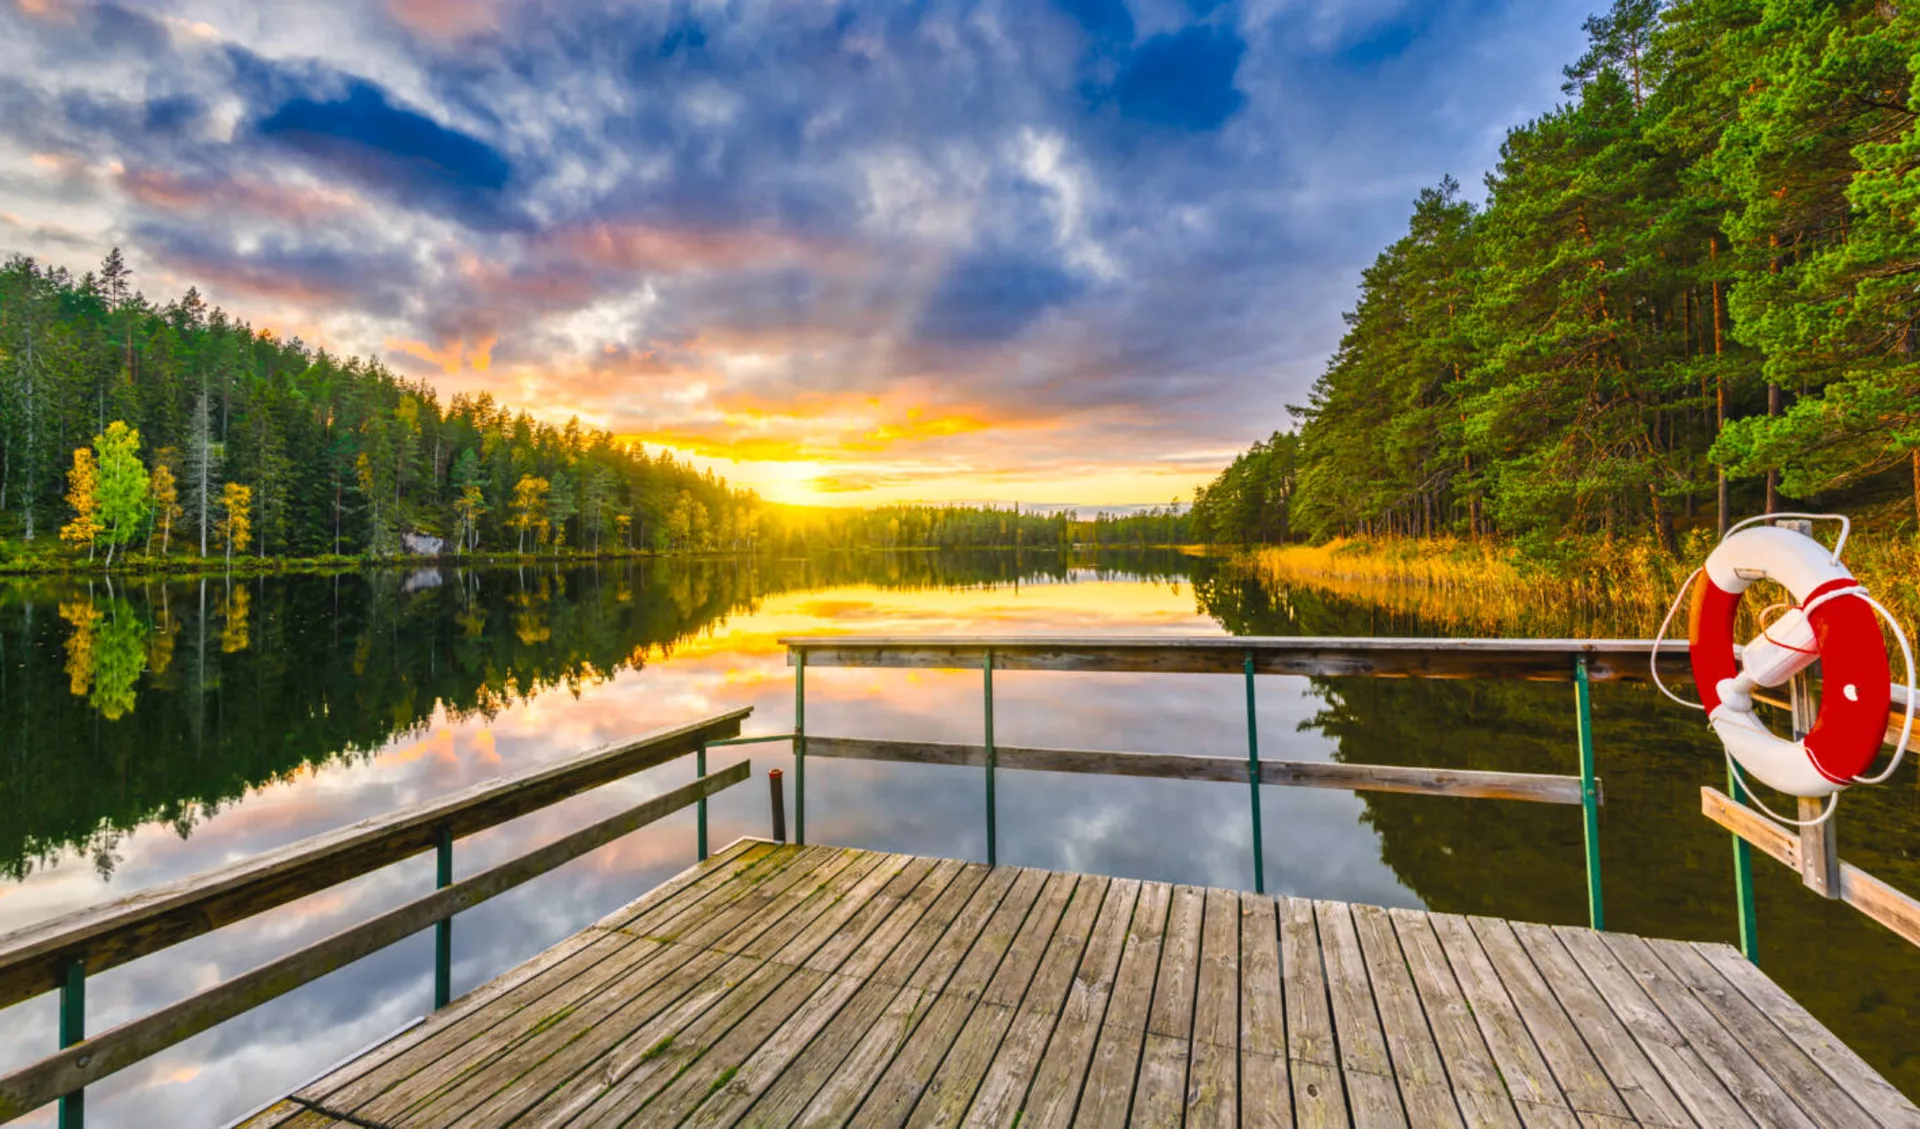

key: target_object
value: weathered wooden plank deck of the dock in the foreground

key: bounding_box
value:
[232,839,1920,1129]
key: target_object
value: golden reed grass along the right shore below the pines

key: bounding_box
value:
[1242,534,1920,637]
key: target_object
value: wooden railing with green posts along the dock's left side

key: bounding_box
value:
[0,709,753,1129]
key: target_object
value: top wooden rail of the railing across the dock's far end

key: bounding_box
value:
[780,636,1686,682]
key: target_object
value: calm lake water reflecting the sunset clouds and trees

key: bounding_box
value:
[0,555,1920,1125]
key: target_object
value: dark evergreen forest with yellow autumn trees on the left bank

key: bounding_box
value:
[0,261,758,557]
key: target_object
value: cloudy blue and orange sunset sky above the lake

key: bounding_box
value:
[0,0,1596,505]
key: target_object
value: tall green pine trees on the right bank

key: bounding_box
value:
[1202,0,1920,545]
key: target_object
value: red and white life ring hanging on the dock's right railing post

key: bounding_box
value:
[1688,526,1905,797]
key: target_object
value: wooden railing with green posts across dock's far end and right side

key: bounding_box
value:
[755,636,1920,962]
